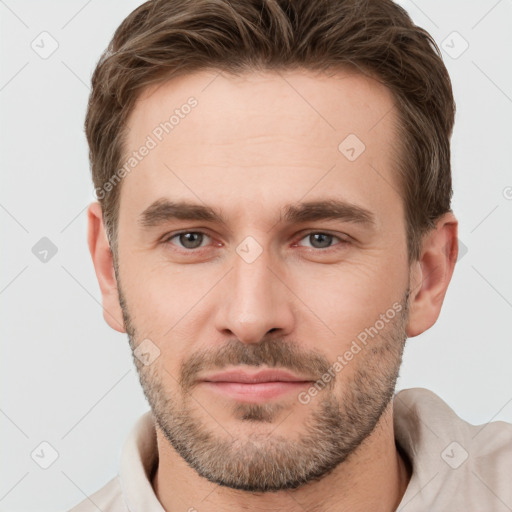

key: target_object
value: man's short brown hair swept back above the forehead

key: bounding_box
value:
[85,0,455,262]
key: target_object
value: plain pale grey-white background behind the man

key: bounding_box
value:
[0,0,512,512]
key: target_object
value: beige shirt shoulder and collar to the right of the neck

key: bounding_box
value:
[393,388,512,512]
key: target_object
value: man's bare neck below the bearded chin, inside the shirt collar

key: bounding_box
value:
[152,403,411,512]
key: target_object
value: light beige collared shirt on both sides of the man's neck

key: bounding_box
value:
[69,388,512,512]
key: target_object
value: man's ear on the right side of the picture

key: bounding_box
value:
[406,212,459,337]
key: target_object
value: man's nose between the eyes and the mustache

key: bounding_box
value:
[216,244,296,344]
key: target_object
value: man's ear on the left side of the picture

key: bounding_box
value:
[87,202,126,332]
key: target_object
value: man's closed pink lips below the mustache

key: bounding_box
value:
[200,370,314,403]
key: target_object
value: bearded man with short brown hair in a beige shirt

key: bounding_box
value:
[73,0,512,512]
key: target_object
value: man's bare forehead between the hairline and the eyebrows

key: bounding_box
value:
[120,70,397,226]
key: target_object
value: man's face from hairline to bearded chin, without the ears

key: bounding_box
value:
[116,71,409,491]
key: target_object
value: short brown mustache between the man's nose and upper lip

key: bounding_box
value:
[179,338,331,391]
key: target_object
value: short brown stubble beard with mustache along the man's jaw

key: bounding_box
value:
[118,280,409,493]
